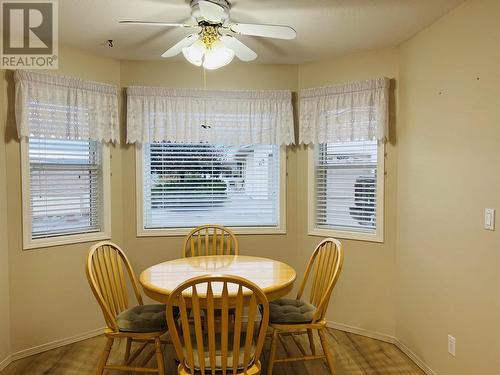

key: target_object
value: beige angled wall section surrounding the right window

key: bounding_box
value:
[295,48,399,336]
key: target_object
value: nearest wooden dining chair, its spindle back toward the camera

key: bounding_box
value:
[167,275,269,375]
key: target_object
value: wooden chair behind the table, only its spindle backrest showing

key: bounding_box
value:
[182,224,238,258]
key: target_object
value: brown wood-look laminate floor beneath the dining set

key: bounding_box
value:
[0,329,424,375]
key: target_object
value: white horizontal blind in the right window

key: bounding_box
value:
[315,140,378,233]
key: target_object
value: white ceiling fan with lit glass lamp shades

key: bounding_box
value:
[120,0,297,69]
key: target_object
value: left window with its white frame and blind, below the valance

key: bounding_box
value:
[22,138,110,248]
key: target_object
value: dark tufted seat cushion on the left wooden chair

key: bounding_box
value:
[116,305,172,332]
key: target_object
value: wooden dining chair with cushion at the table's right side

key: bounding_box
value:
[267,238,344,375]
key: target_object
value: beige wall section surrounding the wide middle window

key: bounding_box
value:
[121,61,297,300]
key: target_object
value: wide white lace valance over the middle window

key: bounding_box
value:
[127,87,294,145]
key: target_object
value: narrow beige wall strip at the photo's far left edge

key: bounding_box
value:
[0,50,10,368]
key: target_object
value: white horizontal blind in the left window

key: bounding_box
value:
[28,138,102,239]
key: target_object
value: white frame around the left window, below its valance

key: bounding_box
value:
[20,138,111,250]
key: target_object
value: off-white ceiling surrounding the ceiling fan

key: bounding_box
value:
[59,0,464,64]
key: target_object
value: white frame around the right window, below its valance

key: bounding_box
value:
[307,142,385,242]
